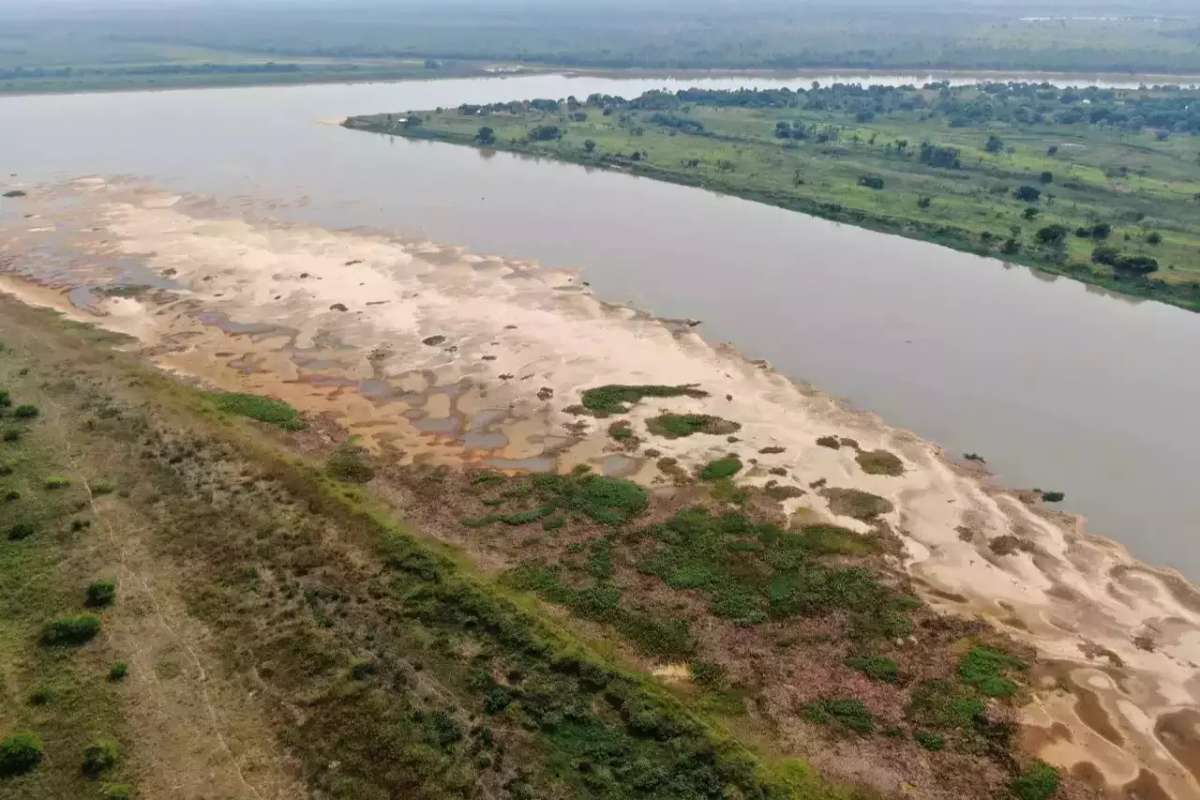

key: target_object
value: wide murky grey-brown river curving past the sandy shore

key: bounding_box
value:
[0,76,1200,579]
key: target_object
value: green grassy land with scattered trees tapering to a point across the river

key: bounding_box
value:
[346,84,1200,309]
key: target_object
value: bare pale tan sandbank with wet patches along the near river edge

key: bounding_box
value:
[0,179,1200,799]
